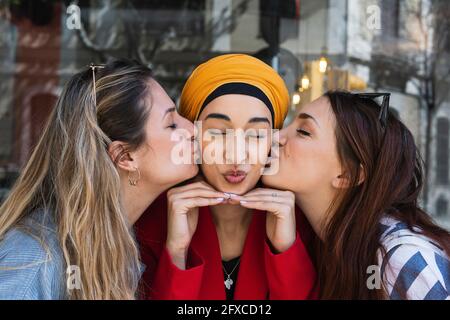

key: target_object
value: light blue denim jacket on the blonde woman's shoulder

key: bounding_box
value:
[0,210,66,300]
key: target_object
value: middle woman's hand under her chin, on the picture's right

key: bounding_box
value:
[239,188,296,253]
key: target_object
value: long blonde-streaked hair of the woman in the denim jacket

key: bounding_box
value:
[0,60,151,299]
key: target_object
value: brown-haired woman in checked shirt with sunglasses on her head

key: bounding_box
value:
[263,92,450,299]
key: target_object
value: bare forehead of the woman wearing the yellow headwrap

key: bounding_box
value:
[199,94,272,124]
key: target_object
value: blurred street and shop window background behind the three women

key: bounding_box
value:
[0,0,450,229]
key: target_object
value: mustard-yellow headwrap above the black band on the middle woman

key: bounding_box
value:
[179,54,289,129]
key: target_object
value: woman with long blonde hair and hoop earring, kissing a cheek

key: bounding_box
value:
[0,60,198,299]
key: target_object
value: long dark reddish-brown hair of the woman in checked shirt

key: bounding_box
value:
[317,91,450,299]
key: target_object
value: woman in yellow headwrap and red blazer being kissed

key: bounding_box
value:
[137,55,315,300]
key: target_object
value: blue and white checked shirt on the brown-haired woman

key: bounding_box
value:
[379,217,450,300]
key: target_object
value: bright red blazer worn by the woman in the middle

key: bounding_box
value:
[136,194,316,300]
